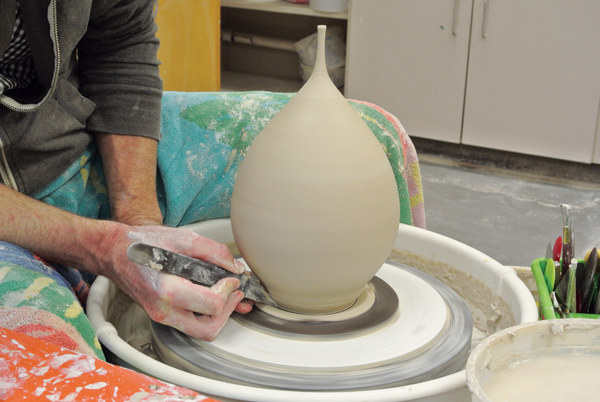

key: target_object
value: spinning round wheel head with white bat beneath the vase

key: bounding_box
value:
[152,262,472,391]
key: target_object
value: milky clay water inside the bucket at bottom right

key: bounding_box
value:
[481,355,600,402]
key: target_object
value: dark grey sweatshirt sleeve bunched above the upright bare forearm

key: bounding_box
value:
[78,0,162,139]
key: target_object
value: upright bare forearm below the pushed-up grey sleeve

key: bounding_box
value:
[96,133,162,225]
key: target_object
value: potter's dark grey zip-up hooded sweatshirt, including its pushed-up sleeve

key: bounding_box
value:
[0,0,162,195]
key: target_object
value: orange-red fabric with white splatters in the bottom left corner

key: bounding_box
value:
[0,327,216,402]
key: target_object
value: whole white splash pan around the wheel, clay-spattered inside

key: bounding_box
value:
[87,219,538,402]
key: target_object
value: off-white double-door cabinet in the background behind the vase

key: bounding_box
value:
[346,0,600,163]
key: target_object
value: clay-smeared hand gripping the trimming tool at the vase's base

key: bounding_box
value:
[106,226,252,341]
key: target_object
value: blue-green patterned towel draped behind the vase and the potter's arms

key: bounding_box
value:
[36,92,422,226]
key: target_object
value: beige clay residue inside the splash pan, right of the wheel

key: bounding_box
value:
[389,249,516,335]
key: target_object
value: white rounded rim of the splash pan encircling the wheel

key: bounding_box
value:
[87,219,538,402]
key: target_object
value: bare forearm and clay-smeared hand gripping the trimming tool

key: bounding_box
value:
[0,184,252,340]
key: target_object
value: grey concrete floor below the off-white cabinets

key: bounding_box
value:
[414,140,600,266]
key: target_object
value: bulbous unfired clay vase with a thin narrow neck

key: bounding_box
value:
[231,26,400,314]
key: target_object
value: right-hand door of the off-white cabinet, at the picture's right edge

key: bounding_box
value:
[462,0,600,163]
